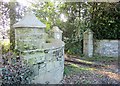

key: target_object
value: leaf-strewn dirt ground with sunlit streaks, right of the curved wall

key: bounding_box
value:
[61,54,120,84]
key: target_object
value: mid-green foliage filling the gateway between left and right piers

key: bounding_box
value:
[56,2,86,54]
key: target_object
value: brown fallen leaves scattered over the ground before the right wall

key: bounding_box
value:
[61,54,120,84]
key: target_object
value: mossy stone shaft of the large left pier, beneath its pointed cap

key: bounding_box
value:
[15,28,45,50]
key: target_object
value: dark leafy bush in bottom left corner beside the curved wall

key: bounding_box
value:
[2,57,32,84]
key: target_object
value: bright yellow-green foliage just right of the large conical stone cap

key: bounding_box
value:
[32,2,60,31]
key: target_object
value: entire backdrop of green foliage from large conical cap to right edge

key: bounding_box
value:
[33,2,120,54]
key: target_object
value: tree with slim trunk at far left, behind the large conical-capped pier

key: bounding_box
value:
[0,1,27,50]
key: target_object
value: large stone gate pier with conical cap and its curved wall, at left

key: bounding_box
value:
[14,13,65,84]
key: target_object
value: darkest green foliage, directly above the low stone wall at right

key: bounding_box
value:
[90,3,120,39]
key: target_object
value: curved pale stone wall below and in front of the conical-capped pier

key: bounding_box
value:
[22,47,64,84]
